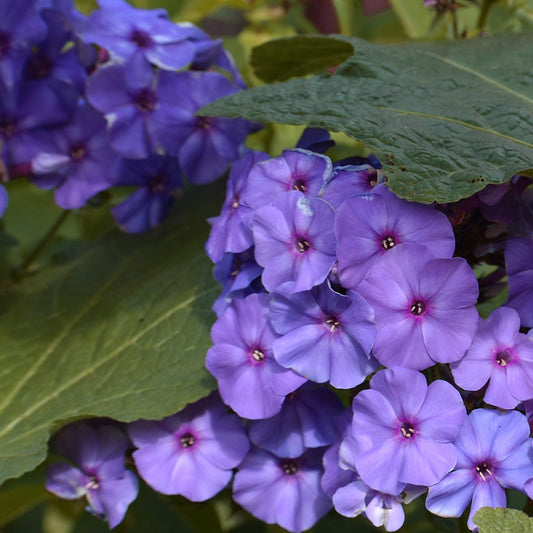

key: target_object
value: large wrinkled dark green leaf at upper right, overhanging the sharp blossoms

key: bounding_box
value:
[200,34,533,203]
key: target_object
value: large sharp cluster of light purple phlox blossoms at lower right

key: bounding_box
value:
[43,135,533,532]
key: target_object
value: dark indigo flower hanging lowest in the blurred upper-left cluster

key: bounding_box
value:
[111,155,181,233]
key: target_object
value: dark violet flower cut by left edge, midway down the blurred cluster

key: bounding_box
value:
[0,78,75,167]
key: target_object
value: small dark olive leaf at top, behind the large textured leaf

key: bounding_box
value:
[252,35,353,82]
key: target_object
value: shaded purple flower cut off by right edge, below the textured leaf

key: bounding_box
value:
[505,238,533,327]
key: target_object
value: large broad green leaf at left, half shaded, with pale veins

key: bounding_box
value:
[0,183,223,482]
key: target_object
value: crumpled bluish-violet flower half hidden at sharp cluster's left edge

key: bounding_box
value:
[212,247,265,316]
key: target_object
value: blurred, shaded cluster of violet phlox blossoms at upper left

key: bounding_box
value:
[0,0,253,233]
